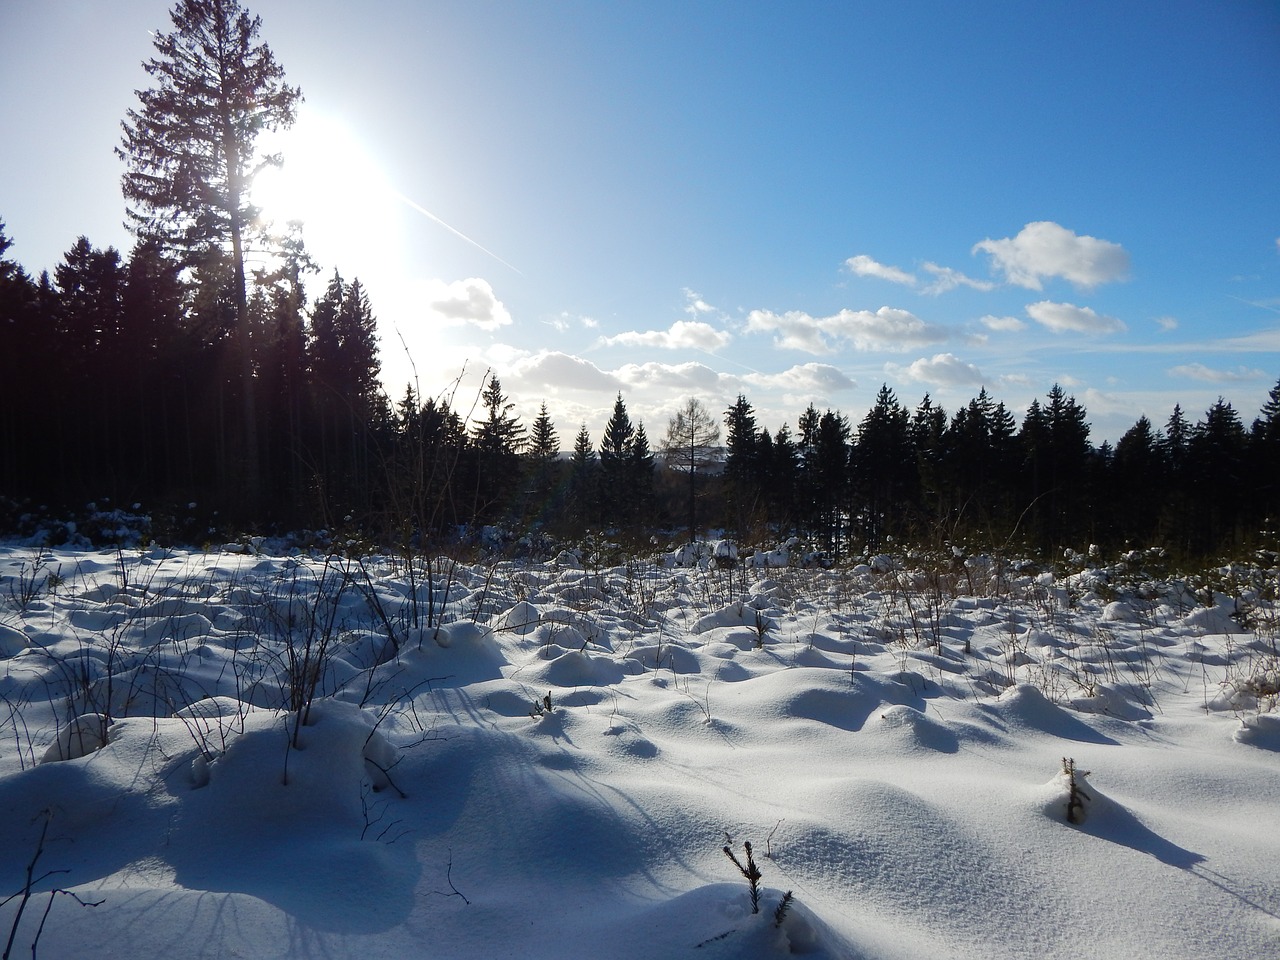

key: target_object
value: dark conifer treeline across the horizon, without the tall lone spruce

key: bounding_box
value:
[0,223,1280,559]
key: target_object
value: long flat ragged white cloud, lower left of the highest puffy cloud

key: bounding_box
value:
[746,307,948,355]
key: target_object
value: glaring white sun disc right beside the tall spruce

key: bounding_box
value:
[250,108,402,265]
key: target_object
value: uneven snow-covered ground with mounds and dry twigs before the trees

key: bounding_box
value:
[0,547,1280,960]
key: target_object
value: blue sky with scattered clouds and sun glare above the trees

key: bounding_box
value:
[0,0,1280,445]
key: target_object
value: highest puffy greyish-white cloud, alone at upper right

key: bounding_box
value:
[973,220,1129,291]
